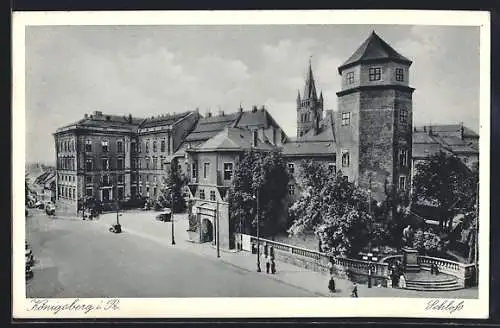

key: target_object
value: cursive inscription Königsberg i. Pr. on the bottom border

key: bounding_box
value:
[27,298,120,314]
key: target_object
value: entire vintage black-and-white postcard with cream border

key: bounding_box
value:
[13,10,490,319]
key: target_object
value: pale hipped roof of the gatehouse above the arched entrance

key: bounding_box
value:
[193,127,275,151]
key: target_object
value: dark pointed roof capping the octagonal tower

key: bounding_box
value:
[339,31,412,73]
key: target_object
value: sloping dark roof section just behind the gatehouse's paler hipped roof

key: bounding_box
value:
[185,112,241,141]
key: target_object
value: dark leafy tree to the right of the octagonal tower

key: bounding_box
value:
[412,152,479,230]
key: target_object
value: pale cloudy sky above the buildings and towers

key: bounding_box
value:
[26,25,480,163]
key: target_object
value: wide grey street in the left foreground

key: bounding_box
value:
[26,210,316,298]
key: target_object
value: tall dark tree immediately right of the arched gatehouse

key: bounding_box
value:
[228,150,289,235]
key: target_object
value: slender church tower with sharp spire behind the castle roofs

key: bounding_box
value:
[297,60,323,140]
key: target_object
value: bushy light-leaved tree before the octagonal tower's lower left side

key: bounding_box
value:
[288,161,372,256]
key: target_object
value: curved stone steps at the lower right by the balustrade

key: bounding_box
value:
[406,271,463,292]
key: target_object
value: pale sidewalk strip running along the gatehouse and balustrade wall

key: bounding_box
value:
[95,211,478,298]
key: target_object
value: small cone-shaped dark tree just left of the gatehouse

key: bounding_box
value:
[159,160,186,213]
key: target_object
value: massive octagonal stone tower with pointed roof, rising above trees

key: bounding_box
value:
[336,32,414,201]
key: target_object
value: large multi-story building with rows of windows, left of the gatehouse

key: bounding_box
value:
[54,111,198,211]
